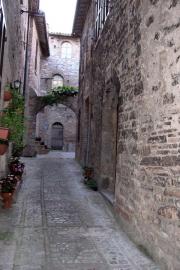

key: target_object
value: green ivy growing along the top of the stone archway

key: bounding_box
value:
[42,86,78,106]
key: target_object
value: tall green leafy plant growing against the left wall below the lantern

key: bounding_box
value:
[0,89,24,156]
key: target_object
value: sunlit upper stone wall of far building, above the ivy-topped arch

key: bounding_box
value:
[41,34,80,94]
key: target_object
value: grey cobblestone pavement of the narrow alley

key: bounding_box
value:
[0,152,159,270]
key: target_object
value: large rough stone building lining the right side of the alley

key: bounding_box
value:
[73,0,180,270]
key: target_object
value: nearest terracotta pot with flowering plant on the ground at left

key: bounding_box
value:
[1,175,17,209]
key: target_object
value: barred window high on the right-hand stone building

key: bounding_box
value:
[96,0,110,38]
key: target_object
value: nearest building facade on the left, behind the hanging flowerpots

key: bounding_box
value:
[0,0,31,176]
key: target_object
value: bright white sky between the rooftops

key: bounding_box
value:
[40,0,77,34]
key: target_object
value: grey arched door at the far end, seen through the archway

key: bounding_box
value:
[51,122,63,150]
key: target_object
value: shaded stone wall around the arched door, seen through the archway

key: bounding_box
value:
[36,104,77,152]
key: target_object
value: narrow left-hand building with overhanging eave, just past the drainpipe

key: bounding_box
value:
[24,0,50,156]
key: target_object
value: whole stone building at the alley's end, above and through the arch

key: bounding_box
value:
[36,33,80,151]
